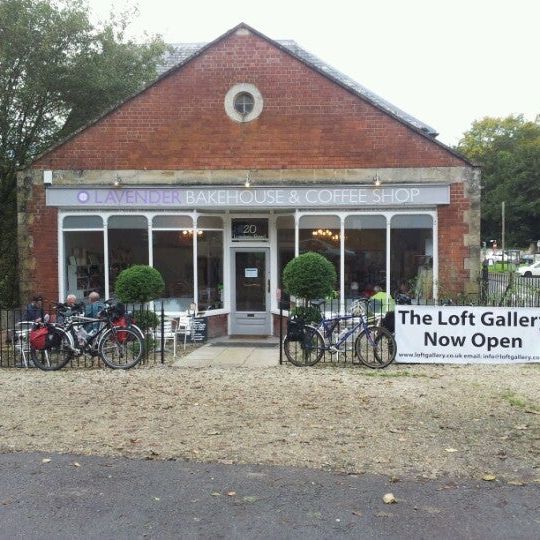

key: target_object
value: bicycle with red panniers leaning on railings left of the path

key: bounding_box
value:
[31,300,144,371]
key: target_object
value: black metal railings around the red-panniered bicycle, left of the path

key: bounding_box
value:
[0,305,171,368]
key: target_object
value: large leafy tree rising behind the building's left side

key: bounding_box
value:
[0,0,165,305]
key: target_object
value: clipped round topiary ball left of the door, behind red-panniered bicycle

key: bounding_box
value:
[114,264,165,303]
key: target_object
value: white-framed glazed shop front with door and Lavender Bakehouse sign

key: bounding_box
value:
[46,184,450,335]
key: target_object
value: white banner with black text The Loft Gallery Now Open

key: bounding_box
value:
[396,306,540,364]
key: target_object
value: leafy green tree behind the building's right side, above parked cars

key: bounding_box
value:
[457,115,540,247]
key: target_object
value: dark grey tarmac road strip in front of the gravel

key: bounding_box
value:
[0,453,540,540]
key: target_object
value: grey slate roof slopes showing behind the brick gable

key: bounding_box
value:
[158,37,438,137]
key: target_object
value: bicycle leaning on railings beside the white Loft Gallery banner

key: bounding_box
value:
[283,300,396,369]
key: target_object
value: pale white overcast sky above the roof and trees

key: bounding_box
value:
[89,0,540,145]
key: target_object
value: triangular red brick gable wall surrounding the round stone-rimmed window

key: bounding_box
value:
[35,30,464,170]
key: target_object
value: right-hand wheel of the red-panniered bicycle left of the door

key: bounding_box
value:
[98,328,143,369]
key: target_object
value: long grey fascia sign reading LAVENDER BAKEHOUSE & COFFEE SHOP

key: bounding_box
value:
[46,184,450,209]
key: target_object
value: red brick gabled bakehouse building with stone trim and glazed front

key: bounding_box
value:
[19,24,480,334]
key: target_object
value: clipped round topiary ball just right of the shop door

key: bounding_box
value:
[283,252,337,300]
